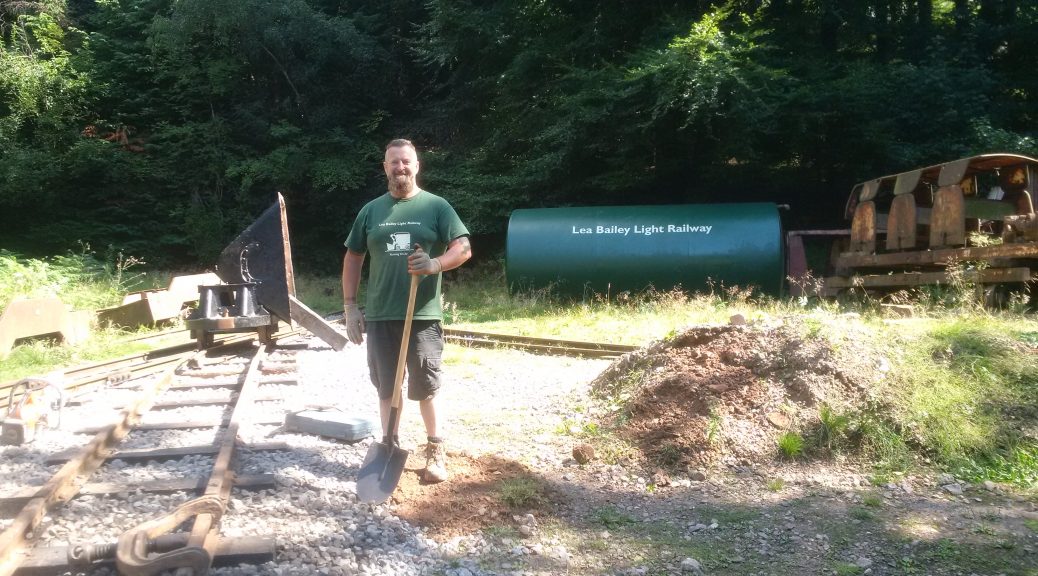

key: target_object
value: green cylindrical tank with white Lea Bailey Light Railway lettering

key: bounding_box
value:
[506,203,785,296]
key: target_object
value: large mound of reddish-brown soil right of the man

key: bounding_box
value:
[593,320,885,467]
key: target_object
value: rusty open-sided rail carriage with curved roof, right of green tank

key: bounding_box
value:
[822,154,1038,295]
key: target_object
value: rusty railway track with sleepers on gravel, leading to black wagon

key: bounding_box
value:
[0,335,307,575]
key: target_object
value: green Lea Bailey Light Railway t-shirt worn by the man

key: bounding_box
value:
[346,190,468,321]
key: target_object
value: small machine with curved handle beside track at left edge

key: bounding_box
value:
[0,378,64,445]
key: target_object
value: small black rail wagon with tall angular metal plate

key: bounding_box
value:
[185,194,348,350]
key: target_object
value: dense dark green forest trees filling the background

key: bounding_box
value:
[0,0,1038,272]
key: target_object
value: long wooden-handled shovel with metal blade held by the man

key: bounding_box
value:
[357,274,421,504]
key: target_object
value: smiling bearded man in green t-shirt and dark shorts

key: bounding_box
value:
[343,139,472,483]
